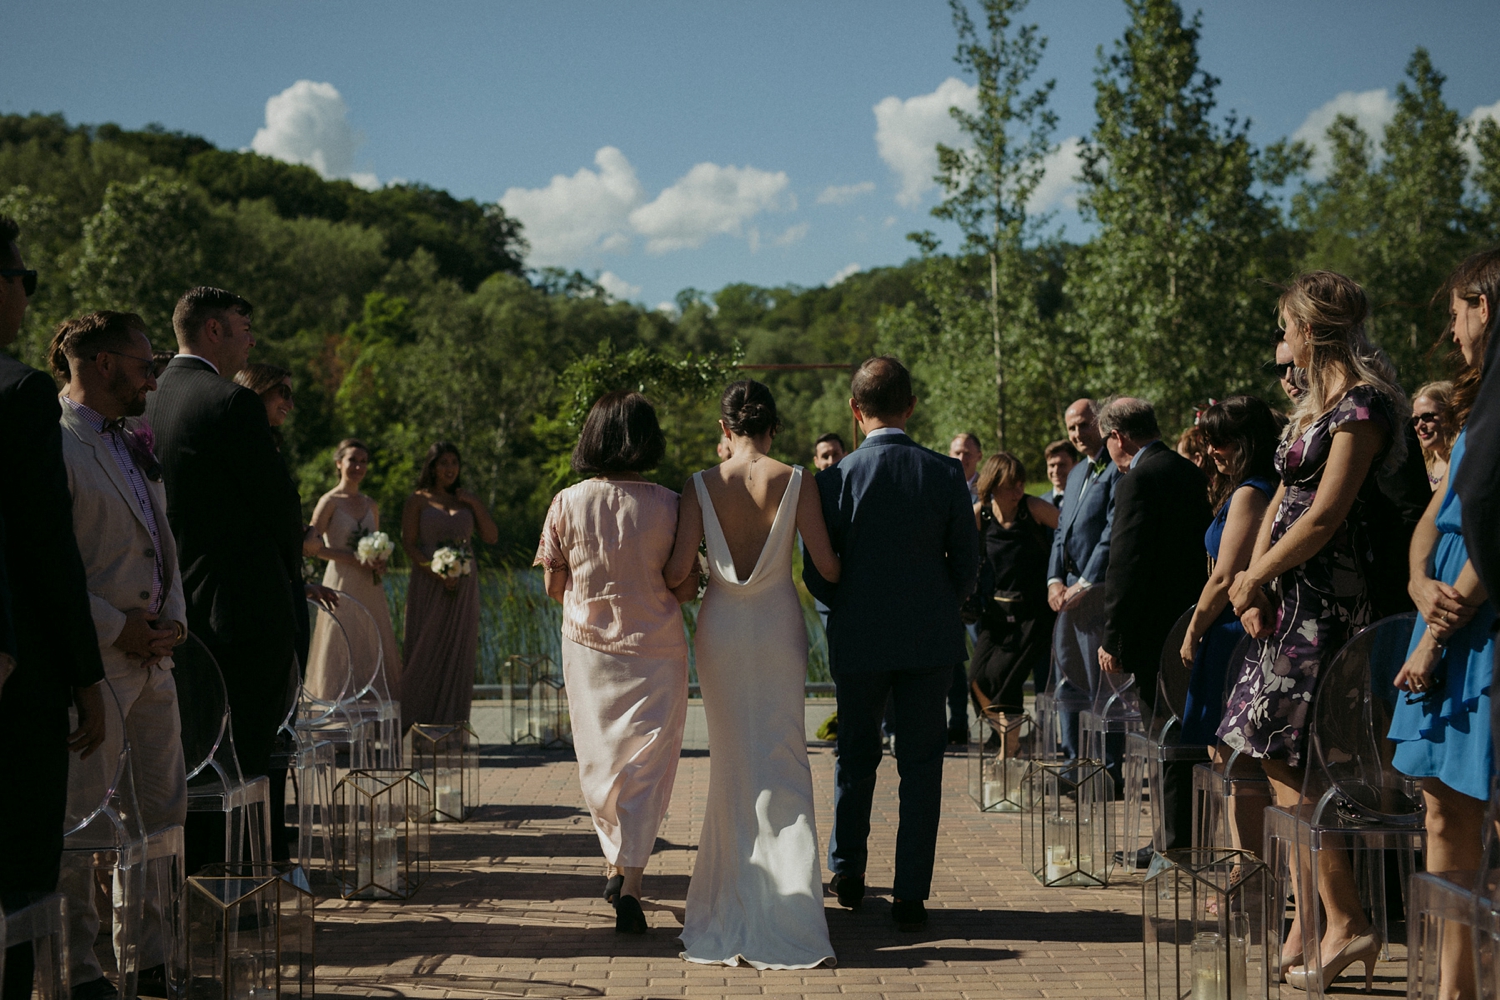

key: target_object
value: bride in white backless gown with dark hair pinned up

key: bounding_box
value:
[665,379,839,969]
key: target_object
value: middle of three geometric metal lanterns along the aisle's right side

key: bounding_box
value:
[1022,760,1115,886]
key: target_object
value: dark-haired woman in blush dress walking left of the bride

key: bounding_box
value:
[536,390,698,934]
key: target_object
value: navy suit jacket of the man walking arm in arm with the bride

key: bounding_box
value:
[803,433,980,679]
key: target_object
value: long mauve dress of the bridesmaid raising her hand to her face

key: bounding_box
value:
[401,504,479,726]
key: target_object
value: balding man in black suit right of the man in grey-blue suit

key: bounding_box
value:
[1100,397,1214,864]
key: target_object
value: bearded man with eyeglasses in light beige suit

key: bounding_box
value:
[48,312,188,1000]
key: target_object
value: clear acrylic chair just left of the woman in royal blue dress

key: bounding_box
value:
[1121,607,1208,868]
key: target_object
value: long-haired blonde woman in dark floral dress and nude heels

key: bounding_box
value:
[1218,271,1409,987]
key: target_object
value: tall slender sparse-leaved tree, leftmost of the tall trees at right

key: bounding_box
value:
[917,0,1058,448]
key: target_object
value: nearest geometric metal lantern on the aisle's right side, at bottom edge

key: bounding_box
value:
[1142,847,1280,1000]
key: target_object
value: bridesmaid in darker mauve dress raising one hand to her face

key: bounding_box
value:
[401,441,500,726]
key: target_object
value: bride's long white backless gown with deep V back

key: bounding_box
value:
[683,466,834,969]
